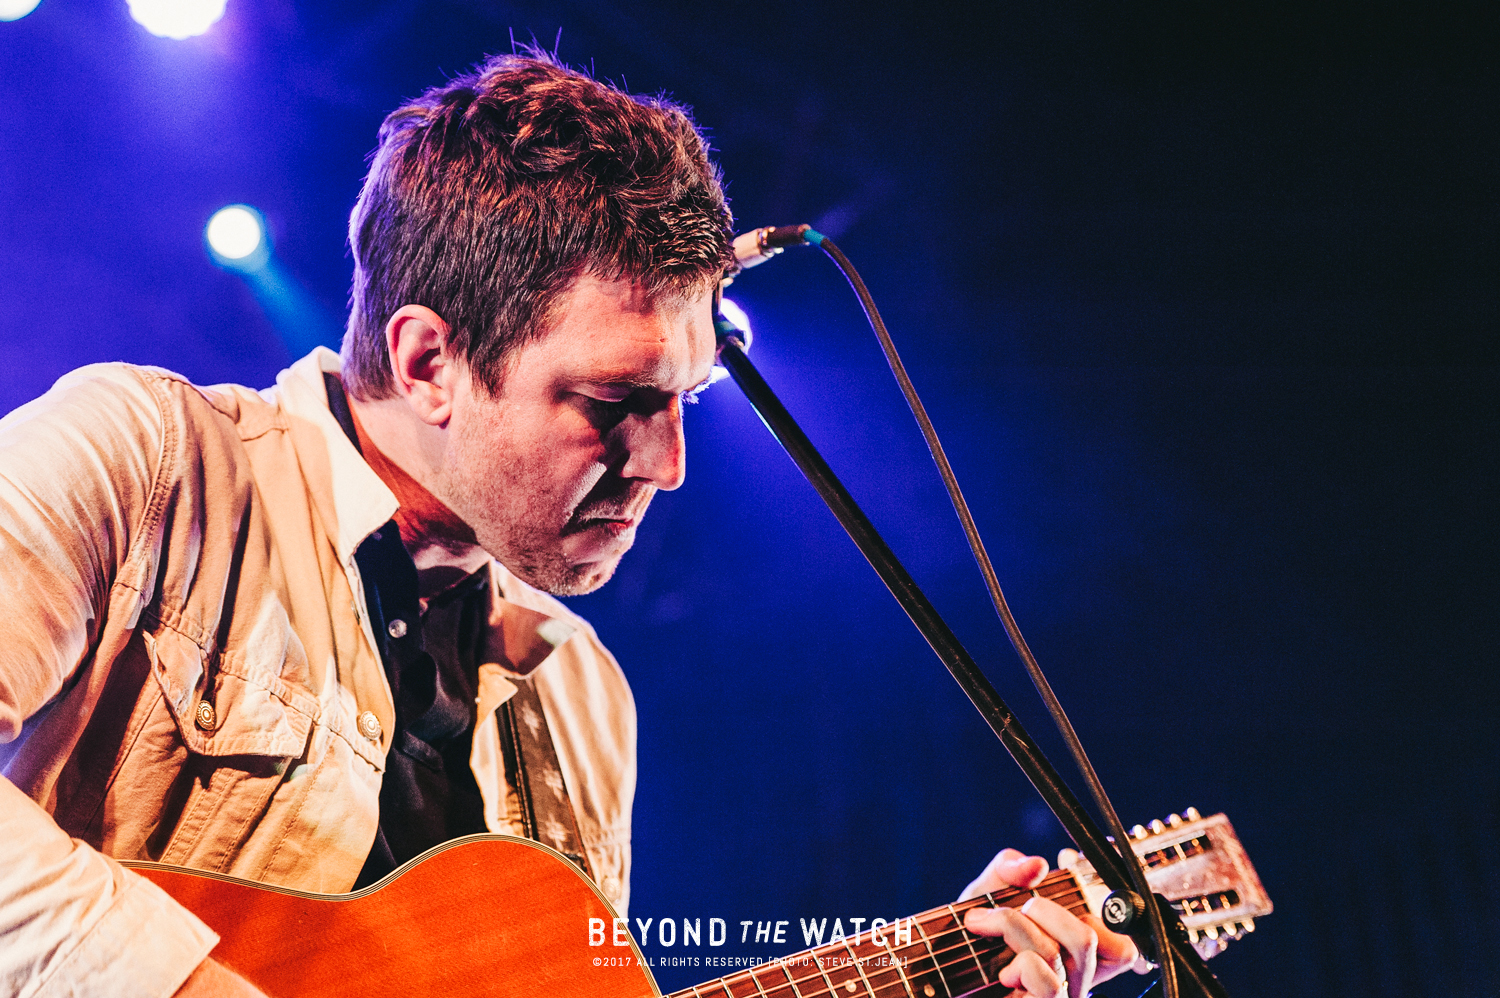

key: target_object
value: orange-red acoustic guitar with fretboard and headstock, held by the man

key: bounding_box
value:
[125,809,1271,998]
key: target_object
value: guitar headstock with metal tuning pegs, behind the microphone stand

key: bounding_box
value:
[1070,807,1272,956]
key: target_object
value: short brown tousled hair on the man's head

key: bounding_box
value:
[344,51,734,399]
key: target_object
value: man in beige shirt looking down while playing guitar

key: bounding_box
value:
[0,56,1136,996]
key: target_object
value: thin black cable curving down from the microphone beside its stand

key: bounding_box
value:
[803,228,1179,998]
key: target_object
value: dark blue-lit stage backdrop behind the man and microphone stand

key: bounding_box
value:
[0,0,1500,998]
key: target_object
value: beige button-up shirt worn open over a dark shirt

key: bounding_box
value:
[0,350,636,998]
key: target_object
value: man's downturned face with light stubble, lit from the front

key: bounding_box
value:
[435,276,714,596]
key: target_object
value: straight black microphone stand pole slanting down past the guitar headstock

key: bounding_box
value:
[719,334,1229,998]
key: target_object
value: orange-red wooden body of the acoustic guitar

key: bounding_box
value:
[125,834,662,998]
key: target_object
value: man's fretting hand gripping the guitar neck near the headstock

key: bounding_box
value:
[960,849,1149,998]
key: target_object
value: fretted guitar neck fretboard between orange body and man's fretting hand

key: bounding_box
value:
[669,870,1088,998]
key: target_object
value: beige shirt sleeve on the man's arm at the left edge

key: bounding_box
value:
[0,366,218,998]
